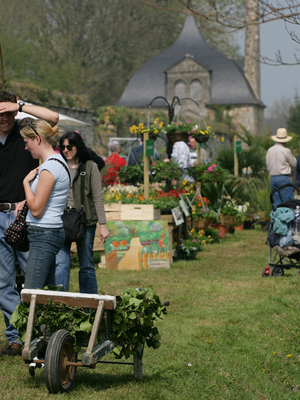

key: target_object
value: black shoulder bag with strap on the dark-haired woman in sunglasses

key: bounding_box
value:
[61,164,86,242]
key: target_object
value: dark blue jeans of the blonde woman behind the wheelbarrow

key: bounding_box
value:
[24,225,65,289]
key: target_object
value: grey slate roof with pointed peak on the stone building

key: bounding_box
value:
[117,15,263,107]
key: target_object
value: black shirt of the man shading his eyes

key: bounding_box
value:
[0,122,39,203]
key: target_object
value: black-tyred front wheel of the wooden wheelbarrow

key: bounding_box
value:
[45,329,77,393]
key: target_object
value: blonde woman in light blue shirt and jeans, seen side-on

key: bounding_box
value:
[15,119,70,289]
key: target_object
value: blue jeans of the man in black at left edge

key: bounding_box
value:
[0,211,28,343]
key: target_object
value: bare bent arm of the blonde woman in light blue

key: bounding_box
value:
[23,168,55,219]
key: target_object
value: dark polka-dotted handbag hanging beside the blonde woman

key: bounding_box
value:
[4,201,29,252]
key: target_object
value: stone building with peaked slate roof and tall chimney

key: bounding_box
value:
[117,15,265,135]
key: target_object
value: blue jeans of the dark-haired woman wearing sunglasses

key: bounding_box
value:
[55,225,98,294]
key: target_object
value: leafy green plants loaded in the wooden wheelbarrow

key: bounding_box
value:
[10,287,166,358]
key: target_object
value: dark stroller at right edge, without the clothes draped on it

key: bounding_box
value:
[262,183,300,277]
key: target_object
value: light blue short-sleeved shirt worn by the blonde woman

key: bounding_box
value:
[26,154,70,228]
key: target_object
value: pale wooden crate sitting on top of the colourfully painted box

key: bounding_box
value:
[121,204,160,221]
